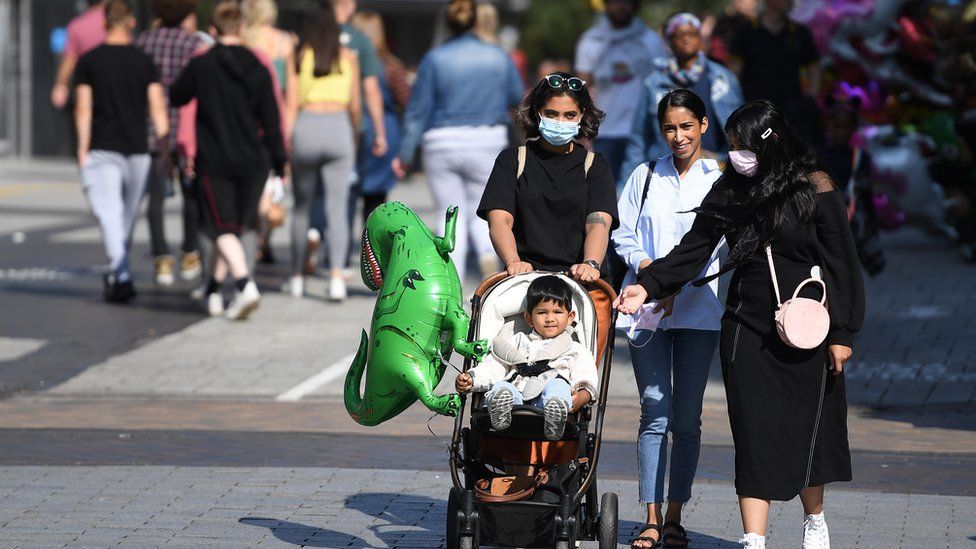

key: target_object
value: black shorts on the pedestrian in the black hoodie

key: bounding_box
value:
[196,173,268,238]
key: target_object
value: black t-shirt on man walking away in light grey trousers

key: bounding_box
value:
[75,44,159,155]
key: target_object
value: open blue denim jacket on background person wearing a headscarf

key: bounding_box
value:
[621,58,743,176]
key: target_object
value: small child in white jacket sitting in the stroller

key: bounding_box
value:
[454,276,597,440]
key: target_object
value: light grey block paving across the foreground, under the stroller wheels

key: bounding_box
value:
[0,467,976,549]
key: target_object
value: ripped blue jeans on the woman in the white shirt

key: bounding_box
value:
[630,329,719,503]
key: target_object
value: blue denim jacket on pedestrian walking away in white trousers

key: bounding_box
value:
[400,33,525,164]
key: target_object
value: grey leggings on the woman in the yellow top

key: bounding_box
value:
[291,112,356,274]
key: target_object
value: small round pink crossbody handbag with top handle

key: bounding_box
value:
[766,244,830,349]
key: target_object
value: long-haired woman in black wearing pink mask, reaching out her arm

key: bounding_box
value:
[616,101,864,549]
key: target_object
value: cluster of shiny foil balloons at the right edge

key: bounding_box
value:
[792,0,976,260]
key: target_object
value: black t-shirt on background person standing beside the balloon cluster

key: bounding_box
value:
[731,22,820,107]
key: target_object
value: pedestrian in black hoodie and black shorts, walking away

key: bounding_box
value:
[170,0,286,320]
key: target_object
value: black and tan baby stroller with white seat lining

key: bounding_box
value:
[447,272,617,549]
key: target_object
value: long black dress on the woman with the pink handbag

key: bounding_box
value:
[638,177,864,501]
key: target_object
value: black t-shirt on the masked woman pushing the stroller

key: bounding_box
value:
[478,141,618,271]
